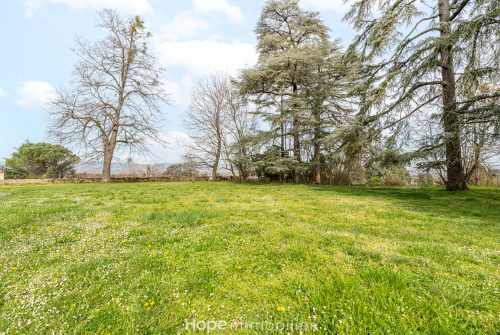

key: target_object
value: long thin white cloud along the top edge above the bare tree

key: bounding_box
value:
[23,0,153,18]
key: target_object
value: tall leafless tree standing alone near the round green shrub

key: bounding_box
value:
[49,10,168,182]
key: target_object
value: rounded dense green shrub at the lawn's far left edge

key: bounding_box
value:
[5,142,79,178]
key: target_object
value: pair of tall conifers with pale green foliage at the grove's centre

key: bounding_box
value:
[239,0,349,183]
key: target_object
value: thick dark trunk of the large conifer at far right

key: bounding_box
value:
[439,0,468,191]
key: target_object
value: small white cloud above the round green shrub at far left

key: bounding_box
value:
[16,81,55,108]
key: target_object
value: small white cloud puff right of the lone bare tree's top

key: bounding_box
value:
[161,12,210,41]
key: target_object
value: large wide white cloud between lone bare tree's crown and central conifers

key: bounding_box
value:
[156,40,257,75]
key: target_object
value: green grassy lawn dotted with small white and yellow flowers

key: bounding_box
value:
[0,183,500,334]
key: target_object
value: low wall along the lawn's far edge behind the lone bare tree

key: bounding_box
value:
[0,177,210,185]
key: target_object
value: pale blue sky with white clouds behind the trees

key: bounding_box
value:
[0,0,354,162]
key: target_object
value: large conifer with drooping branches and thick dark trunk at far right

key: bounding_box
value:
[346,0,500,190]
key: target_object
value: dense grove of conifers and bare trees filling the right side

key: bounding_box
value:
[186,0,500,191]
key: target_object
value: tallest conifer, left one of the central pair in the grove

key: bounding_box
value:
[241,0,329,182]
